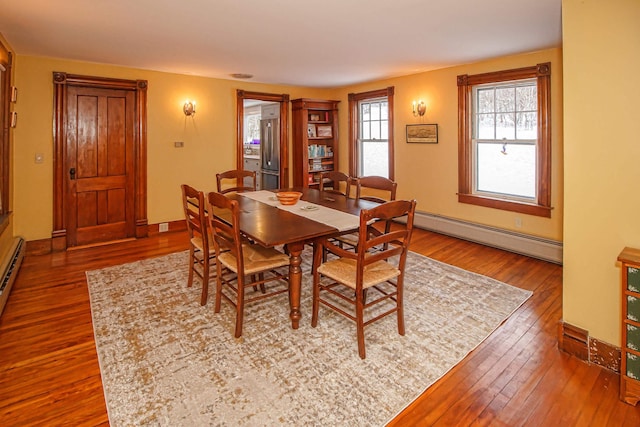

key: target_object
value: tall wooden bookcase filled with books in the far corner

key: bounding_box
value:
[292,98,340,187]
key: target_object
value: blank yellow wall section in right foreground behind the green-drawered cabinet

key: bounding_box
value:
[562,0,640,345]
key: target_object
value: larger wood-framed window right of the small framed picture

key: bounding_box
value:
[458,63,551,217]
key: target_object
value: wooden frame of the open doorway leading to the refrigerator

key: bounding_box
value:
[236,89,289,188]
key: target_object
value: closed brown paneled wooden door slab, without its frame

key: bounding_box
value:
[66,87,135,246]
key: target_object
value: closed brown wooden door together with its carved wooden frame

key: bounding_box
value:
[52,72,147,250]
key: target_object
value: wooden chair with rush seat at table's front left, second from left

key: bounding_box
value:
[207,192,289,338]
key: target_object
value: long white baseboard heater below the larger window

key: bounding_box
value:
[414,212,562,264]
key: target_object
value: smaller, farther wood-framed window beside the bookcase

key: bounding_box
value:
[349,87,394,179]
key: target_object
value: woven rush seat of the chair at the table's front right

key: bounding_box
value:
[318,258,400,289]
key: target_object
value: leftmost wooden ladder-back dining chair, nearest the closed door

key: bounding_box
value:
[182,184,215,305]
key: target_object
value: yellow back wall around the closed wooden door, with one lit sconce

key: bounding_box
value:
[14,55,327,240]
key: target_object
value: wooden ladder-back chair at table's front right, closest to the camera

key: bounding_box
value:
[311,200,416,359]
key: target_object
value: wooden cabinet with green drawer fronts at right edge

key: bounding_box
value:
[618,248,640,405]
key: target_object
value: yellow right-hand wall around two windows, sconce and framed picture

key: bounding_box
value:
[335,49,563,241]
